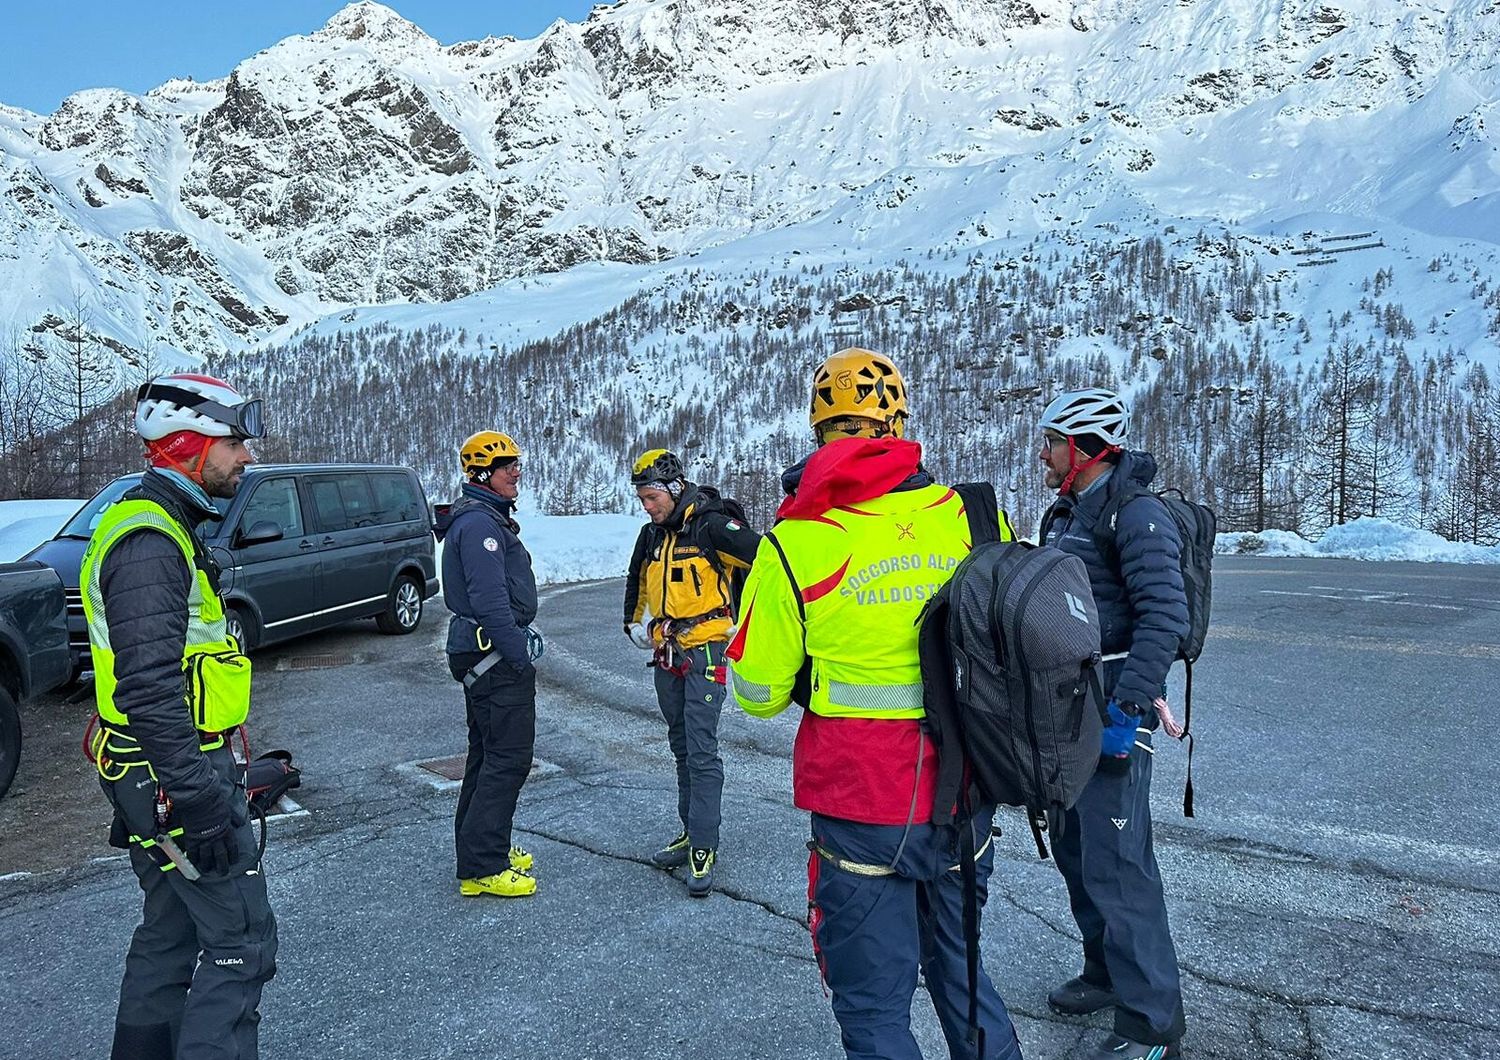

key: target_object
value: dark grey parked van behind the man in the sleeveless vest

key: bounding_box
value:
[26,463,438,676]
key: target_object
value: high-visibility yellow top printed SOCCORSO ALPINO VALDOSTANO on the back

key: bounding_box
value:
[731,484,1014,718]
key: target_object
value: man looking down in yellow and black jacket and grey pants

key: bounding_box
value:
[626,448,761,898]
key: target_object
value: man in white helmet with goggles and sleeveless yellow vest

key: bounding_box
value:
[81,375,276,1060]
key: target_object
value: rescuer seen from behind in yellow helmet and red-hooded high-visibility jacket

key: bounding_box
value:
[729,349,1020,1060]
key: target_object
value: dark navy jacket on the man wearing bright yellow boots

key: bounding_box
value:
[437,483,537,673]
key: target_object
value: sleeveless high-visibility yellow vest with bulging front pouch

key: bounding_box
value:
[80,499,251,733]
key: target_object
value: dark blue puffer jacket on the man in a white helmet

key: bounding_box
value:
[1041,451,1188,717]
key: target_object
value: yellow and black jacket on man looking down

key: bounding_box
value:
[626,484,761,648]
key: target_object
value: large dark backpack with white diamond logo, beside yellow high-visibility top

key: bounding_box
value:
[917,483,1104,827]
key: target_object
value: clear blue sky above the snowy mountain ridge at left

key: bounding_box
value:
[0,0,594,114]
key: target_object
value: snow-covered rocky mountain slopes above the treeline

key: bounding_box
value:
[0,0,1500,358]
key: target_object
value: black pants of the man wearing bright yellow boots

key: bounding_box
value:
[449,652,537,880]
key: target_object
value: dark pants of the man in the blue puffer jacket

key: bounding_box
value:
[1052,730,1184,1045]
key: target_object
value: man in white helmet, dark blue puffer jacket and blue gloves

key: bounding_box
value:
[1038,388,1188,1060]
